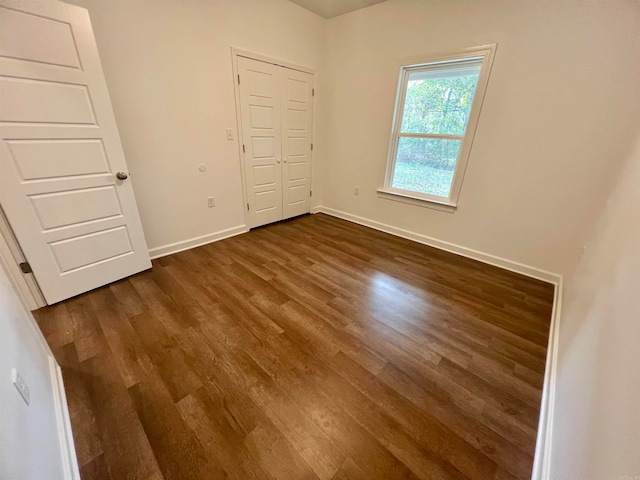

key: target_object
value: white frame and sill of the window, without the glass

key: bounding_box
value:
[378,44,497,212]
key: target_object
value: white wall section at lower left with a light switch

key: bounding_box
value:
[0,258,66,480]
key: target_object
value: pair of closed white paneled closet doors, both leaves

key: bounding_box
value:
[238,56,313,228]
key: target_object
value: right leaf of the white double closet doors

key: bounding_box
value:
[280,67,313,218]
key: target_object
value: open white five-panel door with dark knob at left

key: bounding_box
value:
[0,0,151,304]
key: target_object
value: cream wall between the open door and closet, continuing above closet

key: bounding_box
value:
[63,0,325,253]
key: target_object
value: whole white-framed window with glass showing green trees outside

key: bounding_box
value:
[379,45,495,210]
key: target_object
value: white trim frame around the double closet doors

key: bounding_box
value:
[231,47,316,229]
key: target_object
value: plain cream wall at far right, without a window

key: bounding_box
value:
[550,133,640,480]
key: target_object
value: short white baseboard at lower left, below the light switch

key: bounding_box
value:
[49,355,80,480]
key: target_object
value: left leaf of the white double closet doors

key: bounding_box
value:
[238,57,282,228]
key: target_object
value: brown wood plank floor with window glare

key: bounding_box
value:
[35,214,553,480]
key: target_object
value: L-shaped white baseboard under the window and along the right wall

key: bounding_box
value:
[312,206,562,480]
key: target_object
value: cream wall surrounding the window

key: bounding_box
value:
[318,0,640,274]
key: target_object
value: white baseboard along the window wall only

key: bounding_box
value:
[312,206,562,285]
